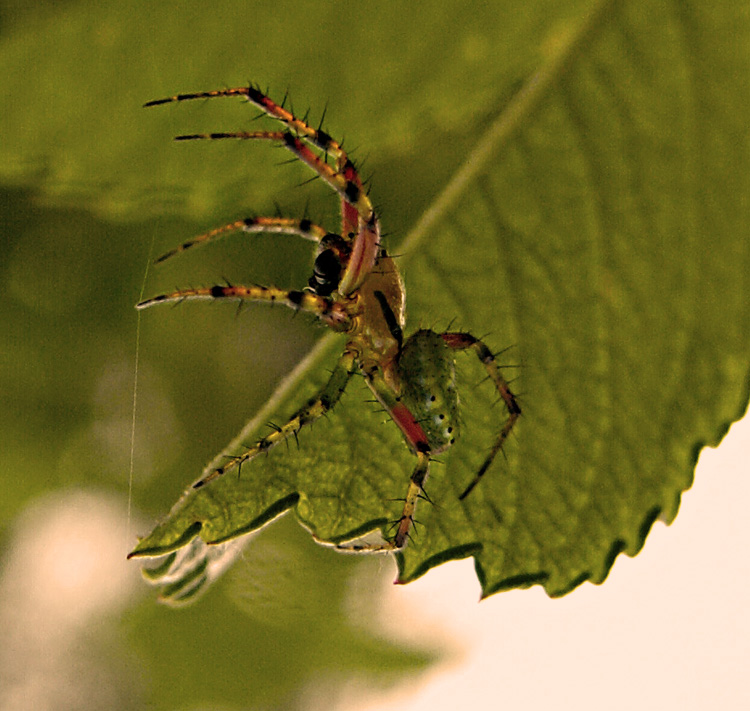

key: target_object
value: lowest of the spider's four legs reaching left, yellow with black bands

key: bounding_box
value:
[136,285,351,331]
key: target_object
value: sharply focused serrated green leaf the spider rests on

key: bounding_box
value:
[126,1,750,595]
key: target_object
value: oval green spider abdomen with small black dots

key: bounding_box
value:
[398,330,459,454]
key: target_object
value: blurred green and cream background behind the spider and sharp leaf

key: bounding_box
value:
[0,0,750,711]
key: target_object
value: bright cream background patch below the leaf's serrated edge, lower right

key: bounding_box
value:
[340,416,750,711]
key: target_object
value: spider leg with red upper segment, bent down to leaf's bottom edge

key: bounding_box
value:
[336,368,430,553]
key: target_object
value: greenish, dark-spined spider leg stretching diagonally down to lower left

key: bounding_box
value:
[193,346,357,489]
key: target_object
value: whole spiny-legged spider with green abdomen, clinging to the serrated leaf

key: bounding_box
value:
[137,86,521,552]
